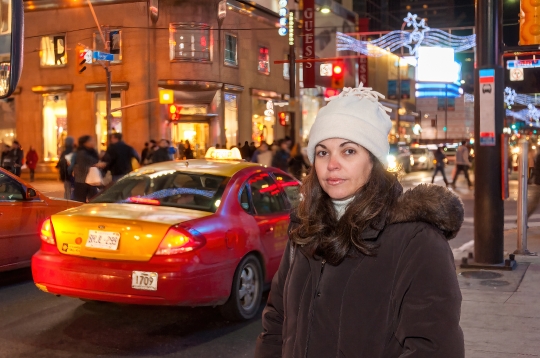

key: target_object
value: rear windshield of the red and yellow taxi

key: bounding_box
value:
[92,170,228,212]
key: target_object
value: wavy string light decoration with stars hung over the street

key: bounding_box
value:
[336,13,476,57]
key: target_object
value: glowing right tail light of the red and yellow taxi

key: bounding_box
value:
[156,226,206,255]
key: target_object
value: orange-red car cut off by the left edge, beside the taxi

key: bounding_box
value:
[0,168,80,271]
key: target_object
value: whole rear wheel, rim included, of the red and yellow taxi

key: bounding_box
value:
[220,255,263,321]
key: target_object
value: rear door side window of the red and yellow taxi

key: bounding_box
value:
[249,173,288,215]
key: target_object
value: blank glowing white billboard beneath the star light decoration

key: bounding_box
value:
[416,47,461,83]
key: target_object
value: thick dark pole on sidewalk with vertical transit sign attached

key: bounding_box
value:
[462,0,513,269]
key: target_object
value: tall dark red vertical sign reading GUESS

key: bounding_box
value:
[302,0,315,88]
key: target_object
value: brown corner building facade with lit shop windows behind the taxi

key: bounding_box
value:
[4,0,289,163]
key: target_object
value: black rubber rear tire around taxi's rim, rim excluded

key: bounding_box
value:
[219,255,263,321]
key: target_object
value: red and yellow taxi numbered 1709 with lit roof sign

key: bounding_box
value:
[32,148,300,320]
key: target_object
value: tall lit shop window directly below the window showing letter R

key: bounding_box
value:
[43,94,67,161]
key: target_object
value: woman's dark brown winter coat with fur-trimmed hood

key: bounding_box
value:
[255,185,464,358]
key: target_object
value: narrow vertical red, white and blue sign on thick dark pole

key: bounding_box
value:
[478,69,495,146]
